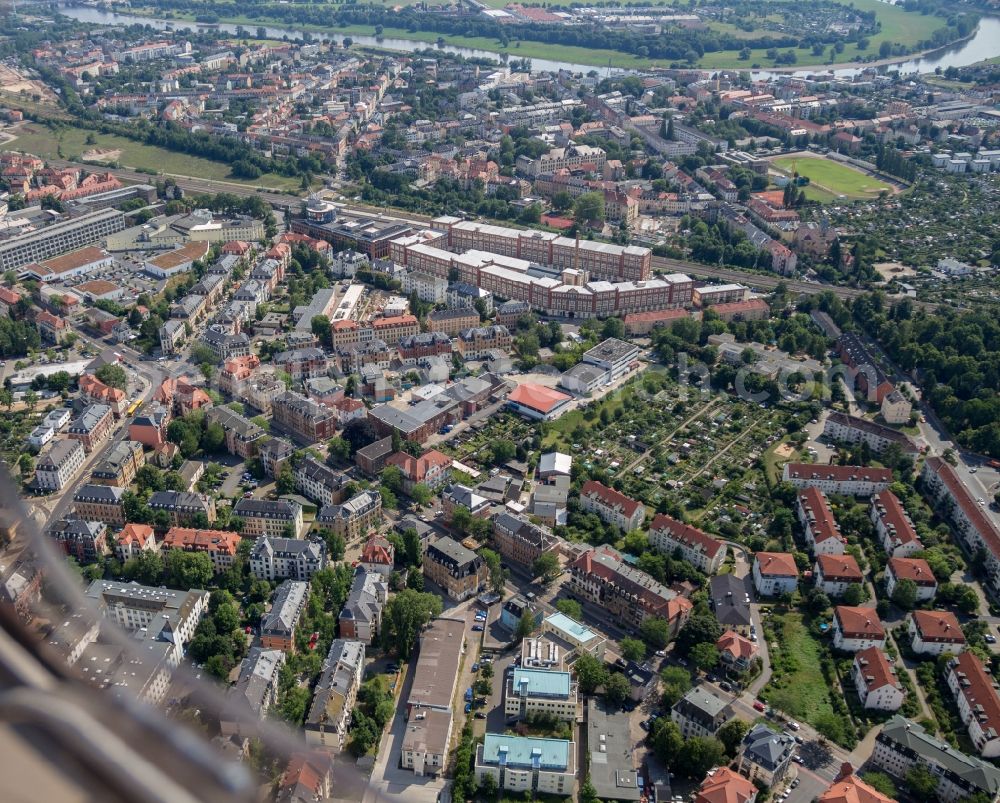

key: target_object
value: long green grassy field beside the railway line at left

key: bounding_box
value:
[6,123,299,190]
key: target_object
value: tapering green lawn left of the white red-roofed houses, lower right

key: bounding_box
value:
[761,611,833,722]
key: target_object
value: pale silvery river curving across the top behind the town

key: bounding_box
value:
[60,6,1000,78]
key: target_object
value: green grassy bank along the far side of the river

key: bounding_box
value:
[94,0,978,74]
